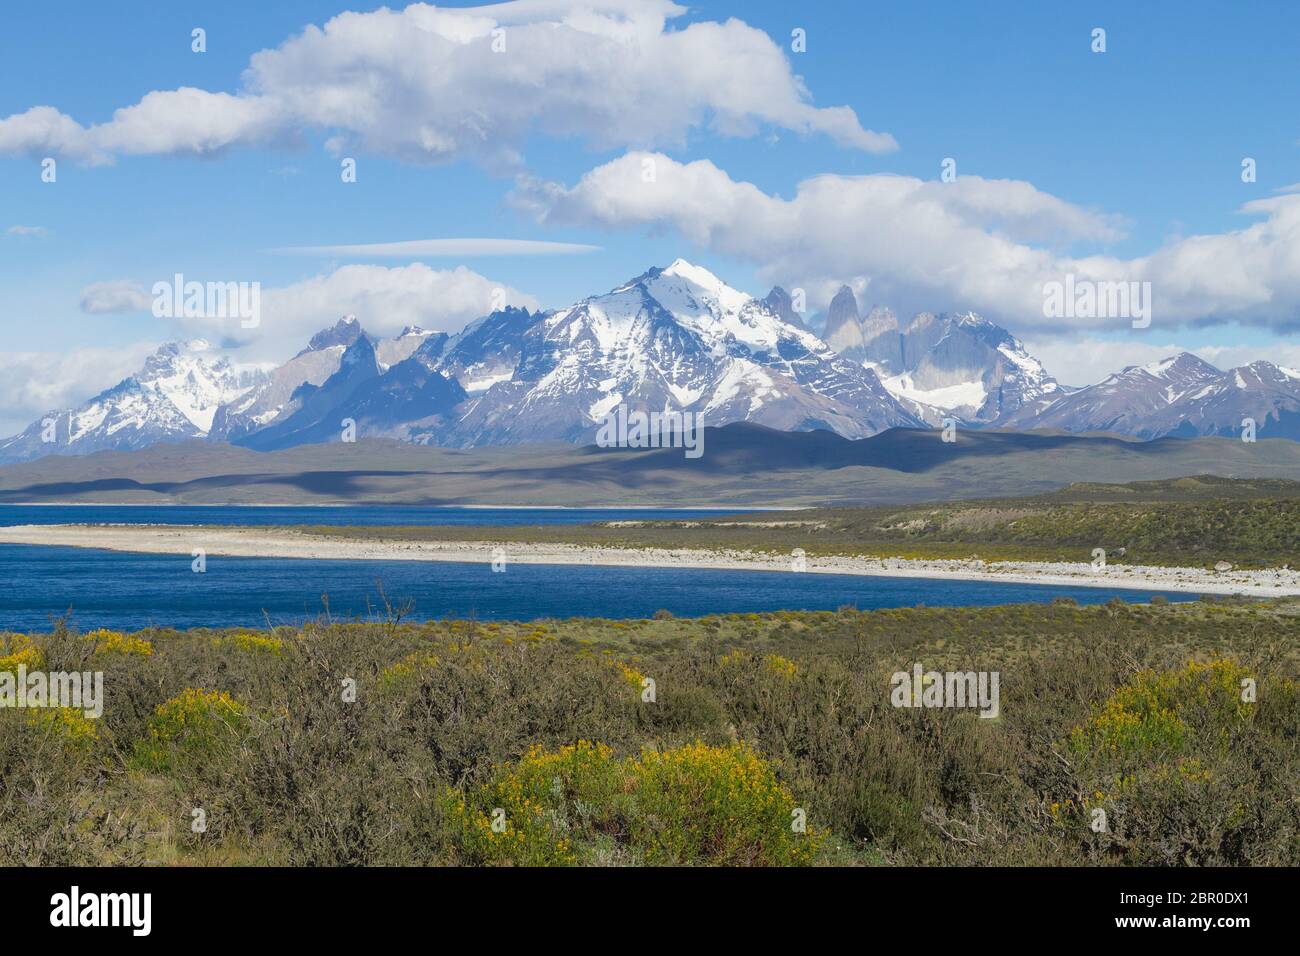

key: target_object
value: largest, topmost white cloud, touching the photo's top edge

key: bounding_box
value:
[0,0,897,164]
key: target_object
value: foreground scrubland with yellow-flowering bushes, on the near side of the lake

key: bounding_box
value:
[0,601,1300,865]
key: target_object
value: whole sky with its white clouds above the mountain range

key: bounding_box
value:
[0,0,1300,433]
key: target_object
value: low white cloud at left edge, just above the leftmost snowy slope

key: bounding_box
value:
[0,342,157,436]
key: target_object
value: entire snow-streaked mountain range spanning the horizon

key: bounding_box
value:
[0,259,1300,463]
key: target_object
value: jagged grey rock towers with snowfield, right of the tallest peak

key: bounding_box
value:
[826,286,1065,424]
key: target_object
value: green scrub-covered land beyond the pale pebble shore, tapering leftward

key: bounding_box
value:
[292,477,1300,568]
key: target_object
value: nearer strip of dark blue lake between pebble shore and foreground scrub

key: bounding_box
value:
[0,545,1190,631]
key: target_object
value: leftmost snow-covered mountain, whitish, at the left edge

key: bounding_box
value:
[0,339,263,462]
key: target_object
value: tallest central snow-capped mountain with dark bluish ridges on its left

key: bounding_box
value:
[220,259,923,449]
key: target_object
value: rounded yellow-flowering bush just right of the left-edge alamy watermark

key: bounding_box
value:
[135,687,248,773]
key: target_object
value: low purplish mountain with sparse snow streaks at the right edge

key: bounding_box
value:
[1005,352,1300,438]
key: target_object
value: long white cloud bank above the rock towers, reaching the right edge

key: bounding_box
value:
[514,152,1300,332]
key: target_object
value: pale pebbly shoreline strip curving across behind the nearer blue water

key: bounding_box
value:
[0,524,1300,597]
